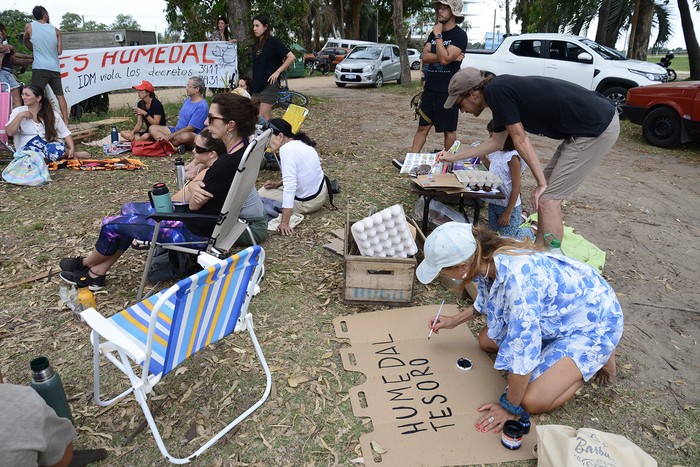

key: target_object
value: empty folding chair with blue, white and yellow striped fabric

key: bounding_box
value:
[81,246,272,464]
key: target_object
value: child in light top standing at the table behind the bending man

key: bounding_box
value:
[482,120,534,240]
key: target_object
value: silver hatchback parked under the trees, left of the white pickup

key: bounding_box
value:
[335,44,401,88]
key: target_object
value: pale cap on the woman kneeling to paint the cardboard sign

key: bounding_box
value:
[416,222,476,284]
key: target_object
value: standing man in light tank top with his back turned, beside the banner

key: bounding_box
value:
[24,5,68,125]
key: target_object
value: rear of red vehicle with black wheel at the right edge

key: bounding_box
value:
[623,81,700,148]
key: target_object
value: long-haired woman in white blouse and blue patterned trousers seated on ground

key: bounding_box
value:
[6,84,90,162]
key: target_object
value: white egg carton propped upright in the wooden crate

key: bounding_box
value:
[350,204,418,258]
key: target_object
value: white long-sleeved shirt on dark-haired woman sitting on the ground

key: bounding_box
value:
[280,141,323,209]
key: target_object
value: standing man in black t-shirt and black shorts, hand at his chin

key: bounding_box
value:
[411,0,467,152]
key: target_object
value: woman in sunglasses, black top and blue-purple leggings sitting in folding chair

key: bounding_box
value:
[60,94,258,290]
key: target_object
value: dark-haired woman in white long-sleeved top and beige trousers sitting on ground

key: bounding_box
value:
[258,118,328,235]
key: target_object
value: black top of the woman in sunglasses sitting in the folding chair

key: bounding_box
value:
[185,145,247,237]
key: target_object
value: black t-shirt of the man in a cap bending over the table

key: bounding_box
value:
[484,75,616,139]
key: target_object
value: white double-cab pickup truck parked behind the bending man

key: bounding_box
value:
[462,33,667,109]
